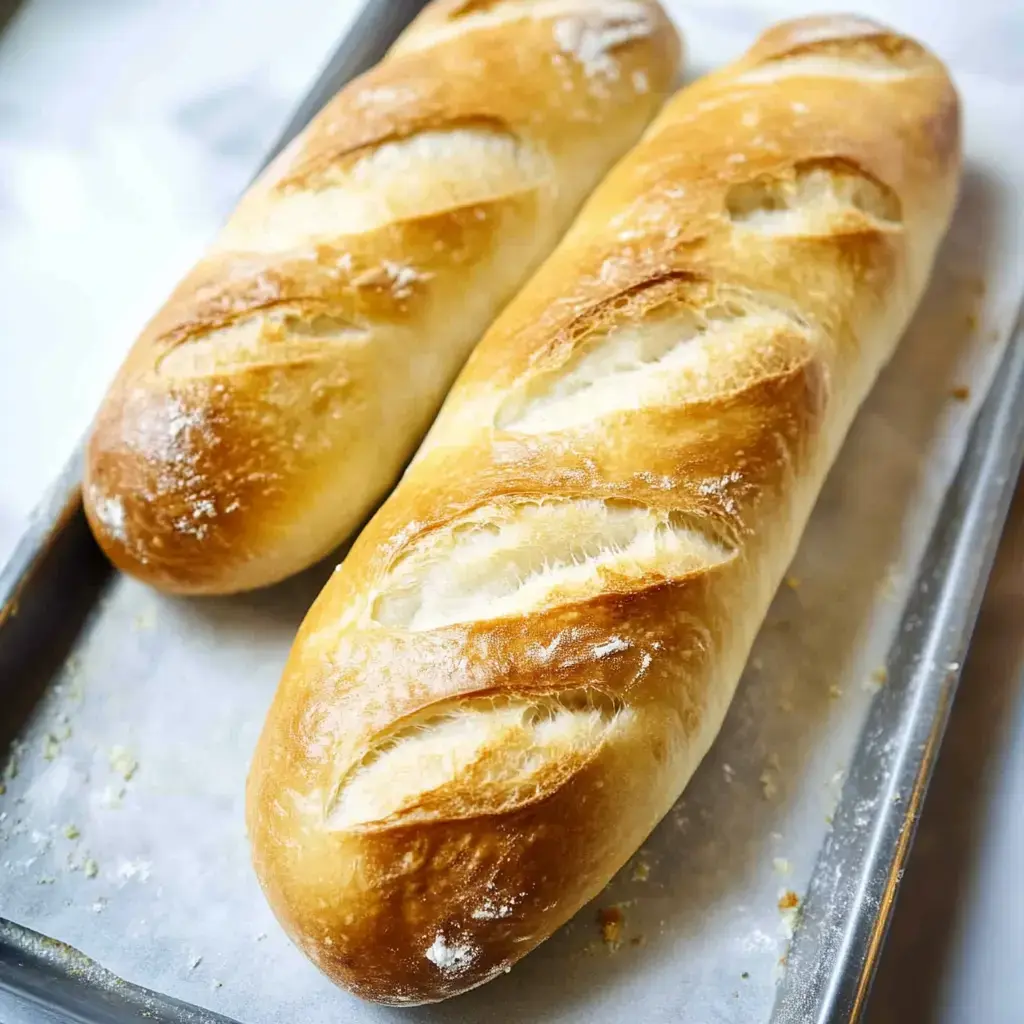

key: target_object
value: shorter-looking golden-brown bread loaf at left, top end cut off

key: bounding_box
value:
[84,0,679,593]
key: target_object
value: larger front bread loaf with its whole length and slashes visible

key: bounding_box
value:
[248,18,961,1004]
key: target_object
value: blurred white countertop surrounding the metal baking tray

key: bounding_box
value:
[0,0,1024,1024]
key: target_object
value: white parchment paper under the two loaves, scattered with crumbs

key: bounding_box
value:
[0,10,1024,1024]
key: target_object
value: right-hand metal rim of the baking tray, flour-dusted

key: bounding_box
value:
[769,300,1024,1024]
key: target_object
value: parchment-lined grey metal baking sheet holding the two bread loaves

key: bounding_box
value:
[0,2,1024,1024]
